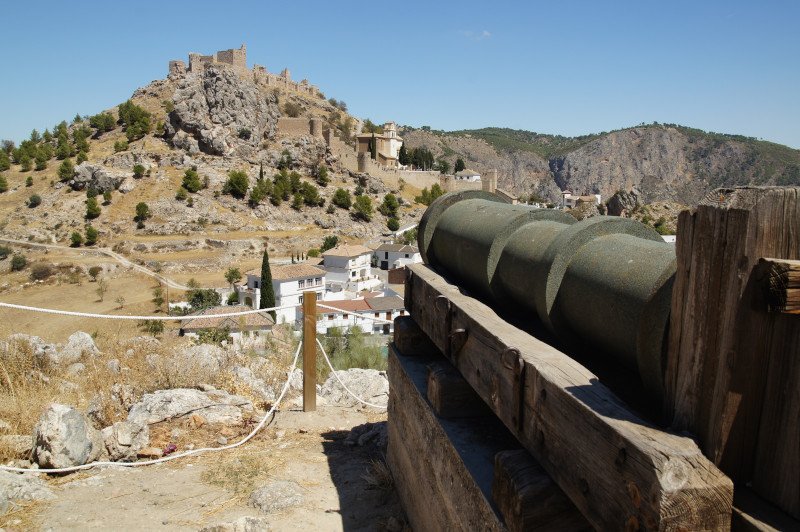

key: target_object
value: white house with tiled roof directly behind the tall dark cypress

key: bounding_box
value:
[239,264,326,323]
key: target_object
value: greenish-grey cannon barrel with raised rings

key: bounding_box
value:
[418,191,676,397]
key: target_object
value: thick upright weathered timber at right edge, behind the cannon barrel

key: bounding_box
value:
[665,187,800,517]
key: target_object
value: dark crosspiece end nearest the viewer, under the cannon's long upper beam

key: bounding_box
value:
[492,449,593,532]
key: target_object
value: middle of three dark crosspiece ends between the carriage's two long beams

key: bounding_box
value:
[428,360,491,418]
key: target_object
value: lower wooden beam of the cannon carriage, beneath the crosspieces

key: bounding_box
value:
[388,348,506,531]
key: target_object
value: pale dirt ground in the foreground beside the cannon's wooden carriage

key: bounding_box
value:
[6,407,405,531]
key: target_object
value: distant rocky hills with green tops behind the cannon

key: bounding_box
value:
[403,124,800,205]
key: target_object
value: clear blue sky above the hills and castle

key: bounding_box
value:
[0,0,800,148]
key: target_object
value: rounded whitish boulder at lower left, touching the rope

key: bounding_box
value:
[33,403,104,468]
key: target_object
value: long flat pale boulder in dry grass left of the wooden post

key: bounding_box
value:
[128,388,253,425]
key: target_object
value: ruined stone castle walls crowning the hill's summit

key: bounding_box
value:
[169,44,319,95]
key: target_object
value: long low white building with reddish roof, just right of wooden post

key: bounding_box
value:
[317,296,406,334]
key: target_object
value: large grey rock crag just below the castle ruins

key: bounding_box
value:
[165,66,280,157]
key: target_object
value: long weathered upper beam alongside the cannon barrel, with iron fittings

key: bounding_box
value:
[407,264,733,530]
